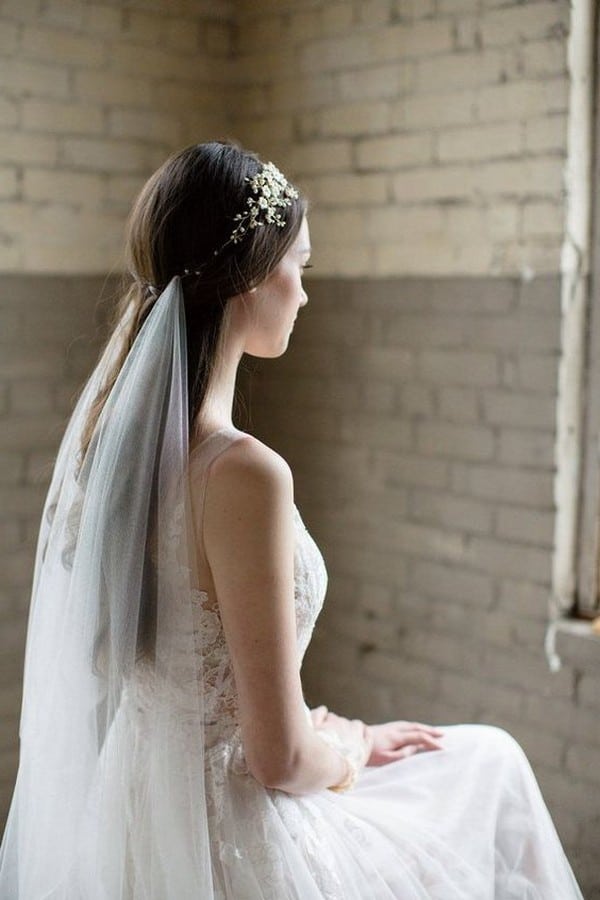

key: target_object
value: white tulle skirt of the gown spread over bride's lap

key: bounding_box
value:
[212,725,582,900]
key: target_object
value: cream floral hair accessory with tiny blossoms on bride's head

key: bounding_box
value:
[214,162,298,256]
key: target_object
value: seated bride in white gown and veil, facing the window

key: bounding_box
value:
[0,142,582,900]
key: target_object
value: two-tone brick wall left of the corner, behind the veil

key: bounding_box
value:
[0,0,232,820]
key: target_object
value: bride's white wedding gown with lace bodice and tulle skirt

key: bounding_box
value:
[115,429,582,900]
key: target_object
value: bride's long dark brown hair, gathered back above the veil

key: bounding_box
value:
[81,141,307,472]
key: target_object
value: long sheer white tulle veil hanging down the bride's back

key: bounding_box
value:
[0,276,214,900]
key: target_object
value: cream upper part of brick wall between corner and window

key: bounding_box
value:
[232,0,569,276]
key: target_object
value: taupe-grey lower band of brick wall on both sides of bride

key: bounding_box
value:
[0,276,600,900]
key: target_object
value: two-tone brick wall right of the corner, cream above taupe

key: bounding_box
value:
[232,0,600,898]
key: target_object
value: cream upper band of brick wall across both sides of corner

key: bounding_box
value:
[0,0,569,276]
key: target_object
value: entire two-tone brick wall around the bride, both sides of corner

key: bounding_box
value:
[0,0,600,900]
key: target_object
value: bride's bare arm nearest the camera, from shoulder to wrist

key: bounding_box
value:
[202,436,367,793]
